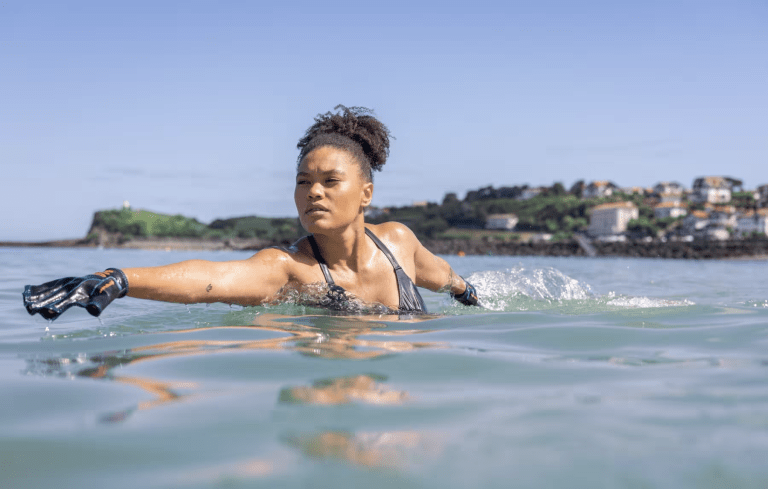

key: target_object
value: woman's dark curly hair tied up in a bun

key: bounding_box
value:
[296,105,394,182]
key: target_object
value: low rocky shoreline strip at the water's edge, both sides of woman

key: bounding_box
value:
[6,238,768,259]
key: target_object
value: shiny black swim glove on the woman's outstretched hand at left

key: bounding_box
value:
[21,268,128,319]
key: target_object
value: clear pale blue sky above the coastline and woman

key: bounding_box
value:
[0,0,768,240]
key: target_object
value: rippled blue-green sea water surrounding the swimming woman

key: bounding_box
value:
[0,248,768,489]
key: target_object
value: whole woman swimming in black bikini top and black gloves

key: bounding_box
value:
[23,106,477,319]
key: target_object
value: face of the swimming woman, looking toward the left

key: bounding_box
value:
[293,146,373,234]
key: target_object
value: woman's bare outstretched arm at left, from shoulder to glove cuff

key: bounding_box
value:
[123,248,291,306]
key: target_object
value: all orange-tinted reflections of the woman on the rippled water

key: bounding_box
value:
[25,314,445,472]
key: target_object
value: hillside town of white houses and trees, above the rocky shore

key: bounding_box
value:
[367,176,768,242]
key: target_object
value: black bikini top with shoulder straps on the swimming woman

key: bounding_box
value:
[308,228,427,313]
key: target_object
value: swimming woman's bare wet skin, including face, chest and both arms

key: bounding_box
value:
[123,146,466,309]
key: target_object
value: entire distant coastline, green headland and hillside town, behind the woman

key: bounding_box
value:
[0,176,768,259]
